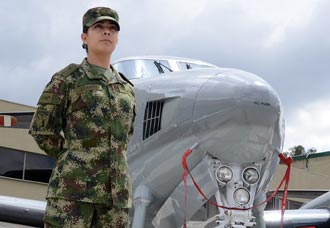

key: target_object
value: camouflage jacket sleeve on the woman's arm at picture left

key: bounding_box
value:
[29,74,66,159]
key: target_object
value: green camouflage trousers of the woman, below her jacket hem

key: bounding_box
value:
[44,198,129,228]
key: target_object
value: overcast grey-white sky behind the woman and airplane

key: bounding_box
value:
[0,0,330,152]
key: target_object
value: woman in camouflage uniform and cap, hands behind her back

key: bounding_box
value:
[30,7,135,228]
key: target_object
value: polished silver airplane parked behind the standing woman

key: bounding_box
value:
[0,56,330,228]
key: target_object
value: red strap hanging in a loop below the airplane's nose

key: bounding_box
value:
[182,148,293,228]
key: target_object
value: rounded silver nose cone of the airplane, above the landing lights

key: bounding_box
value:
[193,70,284,163]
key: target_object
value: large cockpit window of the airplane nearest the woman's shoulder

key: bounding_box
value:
[113,59,172,79]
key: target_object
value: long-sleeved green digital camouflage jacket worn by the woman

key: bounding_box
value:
[30,59,135,208]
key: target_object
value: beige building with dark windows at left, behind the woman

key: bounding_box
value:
[0,99,54,200]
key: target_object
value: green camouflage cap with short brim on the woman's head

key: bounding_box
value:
[83,7,120,32]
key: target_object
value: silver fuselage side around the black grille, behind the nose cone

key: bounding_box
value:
[128,69,219,207]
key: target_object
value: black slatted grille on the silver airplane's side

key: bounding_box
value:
[143,100,164,140]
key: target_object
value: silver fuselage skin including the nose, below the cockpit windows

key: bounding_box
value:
[128,68,284,216]
